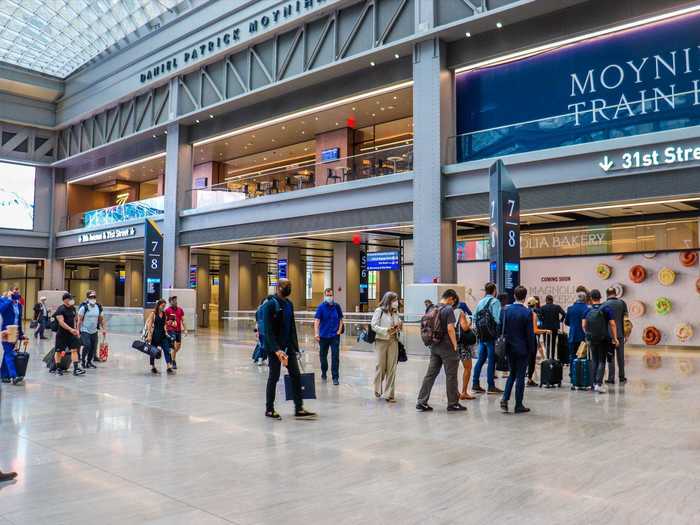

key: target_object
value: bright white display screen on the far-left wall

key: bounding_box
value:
[0,162,35,230]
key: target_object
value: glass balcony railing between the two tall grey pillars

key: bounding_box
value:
[190,144,413,208]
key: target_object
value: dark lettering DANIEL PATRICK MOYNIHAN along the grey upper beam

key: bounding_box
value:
[139,0,327,84]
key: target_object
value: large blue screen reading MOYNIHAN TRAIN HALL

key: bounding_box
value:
[456,10,700,162]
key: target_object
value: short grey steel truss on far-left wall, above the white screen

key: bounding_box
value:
[0,122,56,163]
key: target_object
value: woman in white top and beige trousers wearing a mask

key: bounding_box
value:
[370,292,403,403]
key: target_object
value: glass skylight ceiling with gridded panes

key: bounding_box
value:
[0,0,191,78]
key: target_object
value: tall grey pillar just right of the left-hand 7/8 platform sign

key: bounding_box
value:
[163,112,194,288]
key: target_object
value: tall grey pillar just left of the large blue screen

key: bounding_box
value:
[413,38,457,283]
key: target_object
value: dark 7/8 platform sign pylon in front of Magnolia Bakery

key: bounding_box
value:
[489,160,520,303]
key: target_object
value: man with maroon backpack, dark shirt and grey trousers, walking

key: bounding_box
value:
[416,289,467,412]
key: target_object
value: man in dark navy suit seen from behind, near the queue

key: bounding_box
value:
[501,286,536,414]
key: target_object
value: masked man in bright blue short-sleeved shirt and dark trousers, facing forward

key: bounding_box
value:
[314,288,343,385]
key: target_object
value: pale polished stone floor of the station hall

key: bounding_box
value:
[0,334,700,525]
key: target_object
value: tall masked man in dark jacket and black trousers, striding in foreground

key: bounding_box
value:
[261,279,316,420]
